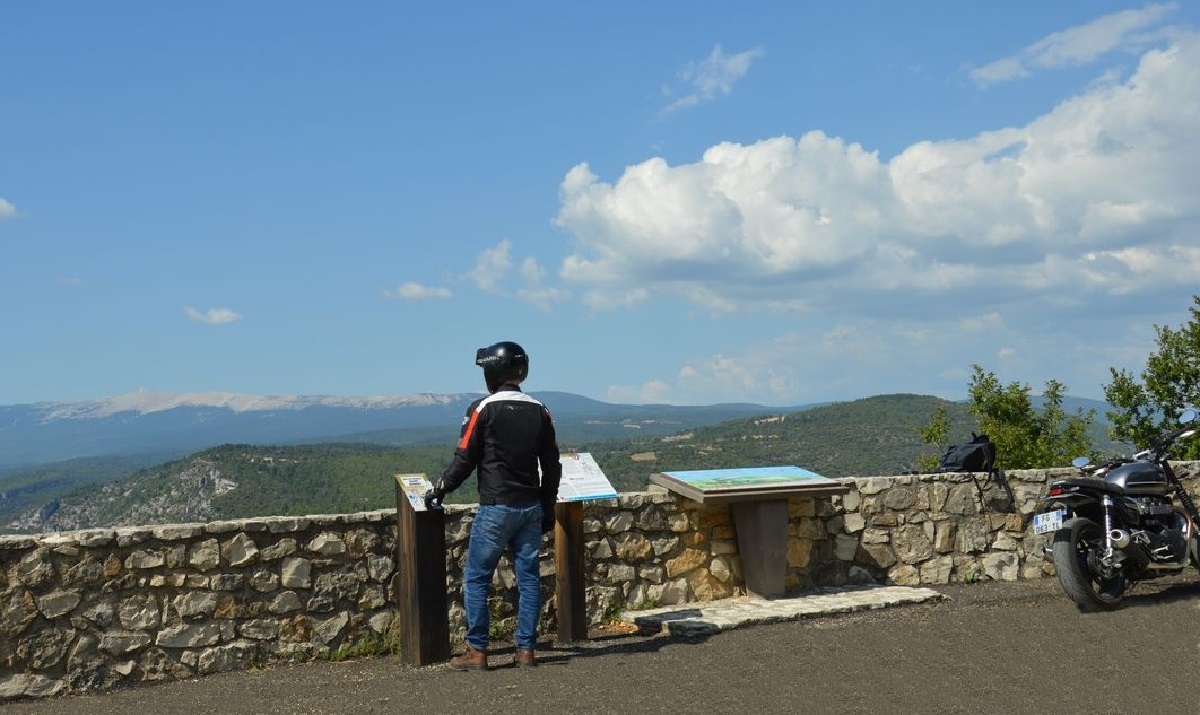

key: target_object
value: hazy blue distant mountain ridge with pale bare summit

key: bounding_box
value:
[0,391,800,470]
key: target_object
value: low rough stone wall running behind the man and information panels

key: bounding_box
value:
[0,463,1200,702]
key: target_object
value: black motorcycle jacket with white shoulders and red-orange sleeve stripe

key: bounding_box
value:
[437,384,563,506]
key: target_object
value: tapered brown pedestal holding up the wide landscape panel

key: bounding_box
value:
[730,499,787,599]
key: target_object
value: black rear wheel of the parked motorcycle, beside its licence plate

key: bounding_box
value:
[1051,517,1126,611]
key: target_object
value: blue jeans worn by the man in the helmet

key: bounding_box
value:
[462,501,541,653]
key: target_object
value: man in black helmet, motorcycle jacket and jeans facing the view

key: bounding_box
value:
[426,341,563,671]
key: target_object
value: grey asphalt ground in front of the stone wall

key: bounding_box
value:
[9,571,1200,715]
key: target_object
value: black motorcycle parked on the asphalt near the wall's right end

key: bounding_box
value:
[1033,409,1200,611]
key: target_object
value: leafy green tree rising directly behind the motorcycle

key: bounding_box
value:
[1104,295,1200,459]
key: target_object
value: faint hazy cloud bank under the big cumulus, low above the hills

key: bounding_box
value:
[657,313,1113,405]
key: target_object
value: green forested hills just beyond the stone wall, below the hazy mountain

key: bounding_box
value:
[0,393,1122,533]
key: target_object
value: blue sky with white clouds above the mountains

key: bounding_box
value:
[0,1,1200,405]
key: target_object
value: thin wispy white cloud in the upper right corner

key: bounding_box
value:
[970,2,1178,84]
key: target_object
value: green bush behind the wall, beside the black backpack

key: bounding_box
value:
[968,365,1096,469]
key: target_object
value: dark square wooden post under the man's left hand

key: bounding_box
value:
[396,477,450,666]
